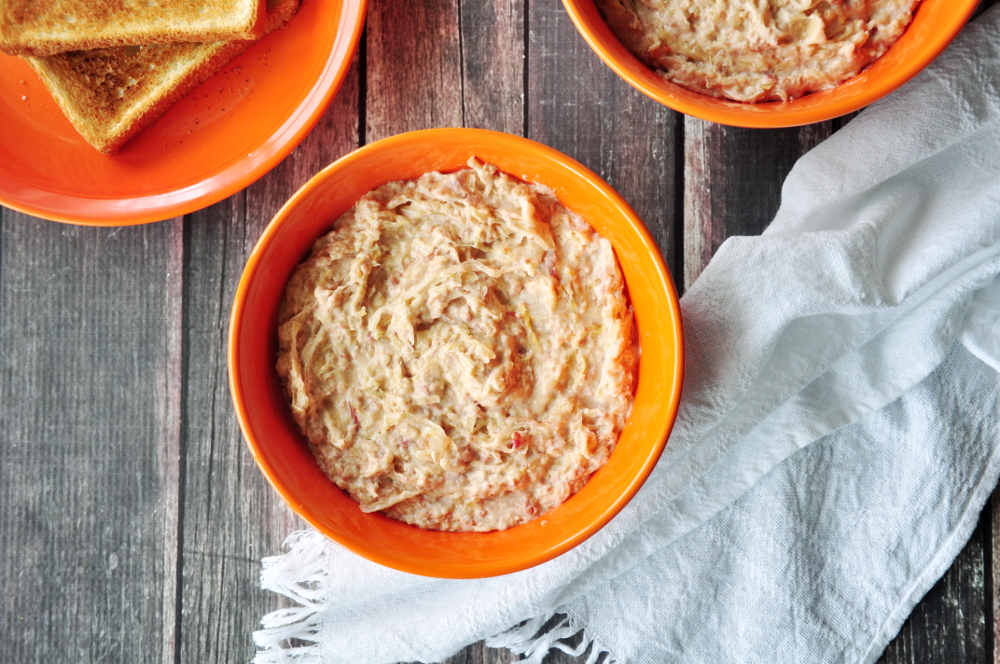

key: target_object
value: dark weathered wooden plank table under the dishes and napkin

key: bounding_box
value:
[0,0,1000,664]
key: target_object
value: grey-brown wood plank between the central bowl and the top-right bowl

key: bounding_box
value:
[526,0,681,278]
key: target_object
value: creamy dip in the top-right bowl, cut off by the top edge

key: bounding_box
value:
[596,0,919,102]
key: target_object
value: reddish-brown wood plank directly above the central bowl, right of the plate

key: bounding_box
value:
[365,0,524,136]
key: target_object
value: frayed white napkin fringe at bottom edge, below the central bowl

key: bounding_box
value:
[486,611,616,664]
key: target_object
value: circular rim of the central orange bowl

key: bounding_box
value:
[227,128,684,579]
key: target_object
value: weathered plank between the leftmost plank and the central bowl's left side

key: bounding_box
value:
[179,59,358,664]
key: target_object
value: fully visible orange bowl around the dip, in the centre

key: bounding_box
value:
[229,129,683,578]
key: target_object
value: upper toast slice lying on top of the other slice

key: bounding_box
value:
[0,0,266,56]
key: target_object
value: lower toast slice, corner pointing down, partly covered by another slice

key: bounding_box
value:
[27,0,299,154]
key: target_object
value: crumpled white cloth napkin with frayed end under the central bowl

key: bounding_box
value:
[254,8,1000,664]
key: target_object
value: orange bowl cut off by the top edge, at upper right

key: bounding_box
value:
[563,0,979,128]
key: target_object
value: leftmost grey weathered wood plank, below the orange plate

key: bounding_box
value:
[0,210,183,664]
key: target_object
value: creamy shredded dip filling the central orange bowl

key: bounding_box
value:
[277,159,638,531]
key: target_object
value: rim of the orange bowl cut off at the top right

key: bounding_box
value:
[562,0,979,129]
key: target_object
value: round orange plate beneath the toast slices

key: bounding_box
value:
[0,0,367,226]
